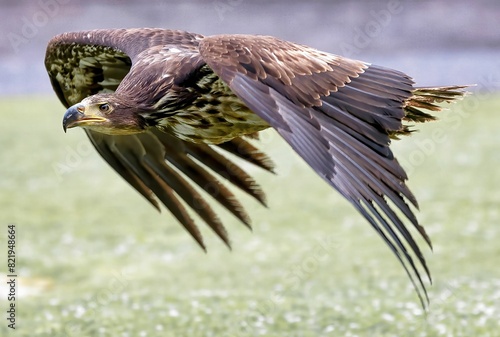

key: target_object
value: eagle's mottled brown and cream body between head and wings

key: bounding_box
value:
[116,45,269,144]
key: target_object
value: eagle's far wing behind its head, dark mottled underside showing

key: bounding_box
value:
[45,29,273,249]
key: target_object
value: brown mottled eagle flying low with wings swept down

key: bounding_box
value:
[45,28,467,305]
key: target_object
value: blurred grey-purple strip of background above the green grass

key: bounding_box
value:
[0,0,500,95]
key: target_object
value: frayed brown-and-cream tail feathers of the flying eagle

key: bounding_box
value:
[392,85,469,138]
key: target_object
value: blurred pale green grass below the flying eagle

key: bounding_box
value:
[0,95,500,337]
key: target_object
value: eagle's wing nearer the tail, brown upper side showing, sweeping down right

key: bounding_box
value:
[199,35,430,303]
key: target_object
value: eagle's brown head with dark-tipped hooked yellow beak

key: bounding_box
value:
[63,94,146,135]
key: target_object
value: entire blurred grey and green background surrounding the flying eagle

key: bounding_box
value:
[0,0,500,337]
